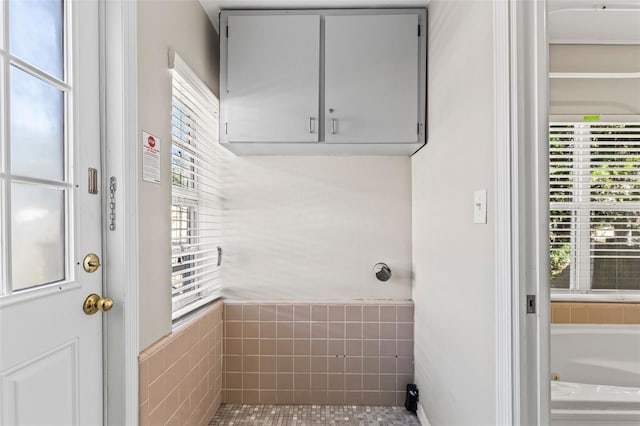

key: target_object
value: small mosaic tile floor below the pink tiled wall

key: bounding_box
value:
[209,404,420,426]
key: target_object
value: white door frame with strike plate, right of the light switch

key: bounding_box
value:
[494,0,550,425]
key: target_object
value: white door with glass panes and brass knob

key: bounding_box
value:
[0,0,102,425]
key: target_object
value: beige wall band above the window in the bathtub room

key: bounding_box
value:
[549,45,640,115]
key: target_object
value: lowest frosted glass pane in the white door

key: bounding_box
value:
[11,183,65,290]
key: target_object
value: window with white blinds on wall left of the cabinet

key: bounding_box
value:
[171,53,222,319]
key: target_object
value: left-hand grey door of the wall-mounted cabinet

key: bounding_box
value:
[221,15,320,142]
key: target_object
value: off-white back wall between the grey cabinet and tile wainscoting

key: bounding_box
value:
[223,154,411,300]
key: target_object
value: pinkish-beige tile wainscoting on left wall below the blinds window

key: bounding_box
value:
[138,300,223,426]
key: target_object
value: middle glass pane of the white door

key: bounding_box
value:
[9,67,64,180]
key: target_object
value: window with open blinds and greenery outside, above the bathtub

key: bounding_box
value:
[549,120,640,293]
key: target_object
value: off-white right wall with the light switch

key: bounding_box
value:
[412,0,496,426]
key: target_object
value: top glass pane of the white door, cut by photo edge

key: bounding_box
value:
[9,0,64,80]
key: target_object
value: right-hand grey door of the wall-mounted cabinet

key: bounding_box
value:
[325,14,421,143]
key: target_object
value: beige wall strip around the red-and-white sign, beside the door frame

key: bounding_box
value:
[137,0,219,349]
